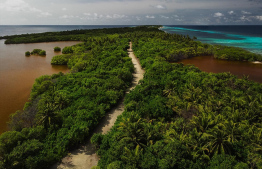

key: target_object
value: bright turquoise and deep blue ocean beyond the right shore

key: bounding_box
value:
[162,25,262,54]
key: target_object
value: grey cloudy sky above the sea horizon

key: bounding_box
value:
[0,0,262,25]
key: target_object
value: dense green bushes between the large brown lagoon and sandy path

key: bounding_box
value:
[0,27,141,169]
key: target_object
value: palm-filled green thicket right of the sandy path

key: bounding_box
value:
[91,33,262,169]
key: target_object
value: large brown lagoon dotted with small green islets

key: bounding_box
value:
[0,40,79,134]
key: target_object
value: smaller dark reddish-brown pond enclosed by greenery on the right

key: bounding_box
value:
[179,56,262,83]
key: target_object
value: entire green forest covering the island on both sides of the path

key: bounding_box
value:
[0,26,262,168]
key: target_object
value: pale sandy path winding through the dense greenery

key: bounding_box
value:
[51,43,144,169]
